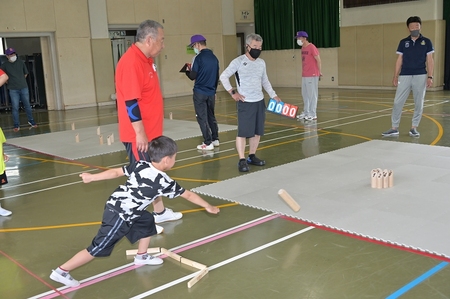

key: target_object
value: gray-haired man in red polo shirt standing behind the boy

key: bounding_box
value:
[115,20,183,233]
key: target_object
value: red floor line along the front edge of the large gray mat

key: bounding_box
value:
[281,216,450,262]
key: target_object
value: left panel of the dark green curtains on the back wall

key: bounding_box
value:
[254,0,295,50]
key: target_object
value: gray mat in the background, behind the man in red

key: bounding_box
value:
[7,119,237,160]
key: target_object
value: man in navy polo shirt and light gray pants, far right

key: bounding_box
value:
[382,16,434,137]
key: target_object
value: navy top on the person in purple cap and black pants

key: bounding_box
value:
[192,49,219,96]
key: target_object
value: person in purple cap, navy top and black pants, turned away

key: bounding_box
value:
[186,34,219,150]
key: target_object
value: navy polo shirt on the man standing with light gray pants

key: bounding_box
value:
[397,34,434,76]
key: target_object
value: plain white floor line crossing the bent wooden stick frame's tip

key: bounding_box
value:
[130,226,314,299]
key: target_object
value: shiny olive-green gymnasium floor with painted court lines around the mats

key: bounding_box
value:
[0,88,450,299]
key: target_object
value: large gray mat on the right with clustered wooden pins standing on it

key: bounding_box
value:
[195,140,450,257]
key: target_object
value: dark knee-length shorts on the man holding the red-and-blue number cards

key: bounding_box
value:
[236,99,266,138]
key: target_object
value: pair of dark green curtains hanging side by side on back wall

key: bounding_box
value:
[254,0,340,50]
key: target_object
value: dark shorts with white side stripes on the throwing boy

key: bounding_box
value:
[86,206,157,257]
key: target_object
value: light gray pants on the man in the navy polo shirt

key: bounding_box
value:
[392,74,428,128]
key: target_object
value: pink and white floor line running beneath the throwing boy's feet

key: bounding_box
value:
[32,214,280,299]
